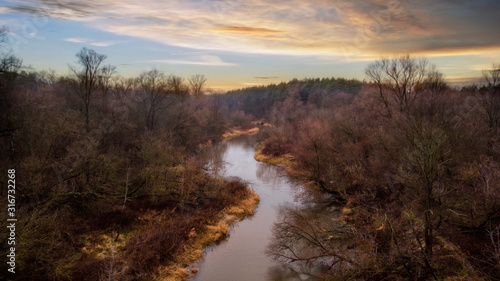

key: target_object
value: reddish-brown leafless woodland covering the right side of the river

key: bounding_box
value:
[261,56,500,280]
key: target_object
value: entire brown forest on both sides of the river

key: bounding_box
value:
[0,22,500,280]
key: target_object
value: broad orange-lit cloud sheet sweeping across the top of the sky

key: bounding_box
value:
[9,0,500,58]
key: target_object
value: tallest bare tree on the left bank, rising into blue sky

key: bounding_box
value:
[69,48,107,132]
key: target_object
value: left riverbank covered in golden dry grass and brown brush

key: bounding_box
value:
[79,180,260,281]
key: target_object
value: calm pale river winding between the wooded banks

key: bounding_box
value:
[193,137,305,281]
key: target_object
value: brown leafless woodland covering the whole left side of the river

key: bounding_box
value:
[0,25,247,280]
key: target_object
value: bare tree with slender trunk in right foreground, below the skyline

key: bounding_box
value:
[395,118,453,272]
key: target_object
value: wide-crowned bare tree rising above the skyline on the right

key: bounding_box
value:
[365,55,430,116]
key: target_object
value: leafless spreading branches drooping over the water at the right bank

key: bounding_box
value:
[266,203,367,280]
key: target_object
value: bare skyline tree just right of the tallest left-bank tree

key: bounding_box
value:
[137,69,178,130]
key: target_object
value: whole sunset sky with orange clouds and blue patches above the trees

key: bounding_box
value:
[0,0,500,90]
